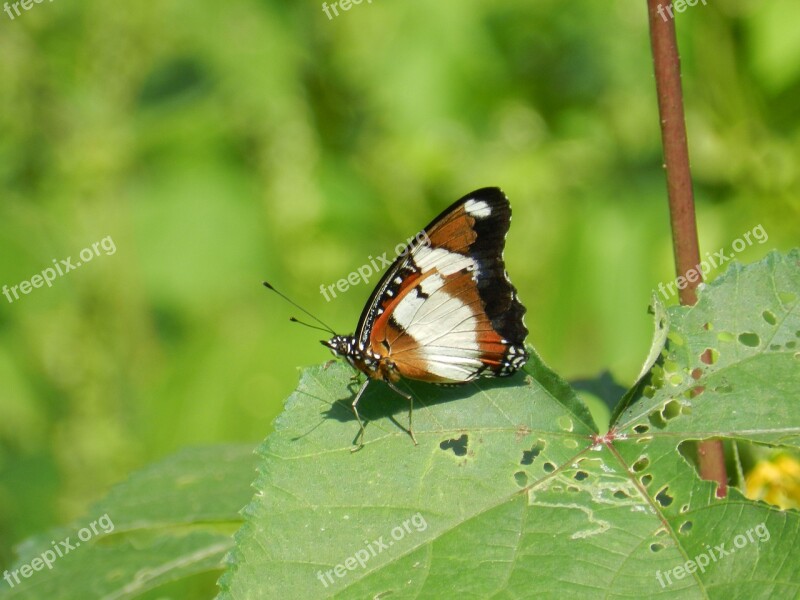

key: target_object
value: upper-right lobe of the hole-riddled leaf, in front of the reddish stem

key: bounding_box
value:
[616,250,800,447]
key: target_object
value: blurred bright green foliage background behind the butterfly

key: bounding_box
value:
[0,0,800,568]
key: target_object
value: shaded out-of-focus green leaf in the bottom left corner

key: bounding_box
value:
[0,446,255,600]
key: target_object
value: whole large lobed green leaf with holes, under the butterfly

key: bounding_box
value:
[220,252,800,600]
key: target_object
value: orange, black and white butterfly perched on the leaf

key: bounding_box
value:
[322,187,528,451]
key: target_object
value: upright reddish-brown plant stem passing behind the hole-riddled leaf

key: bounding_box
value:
[647,0,727,498]
